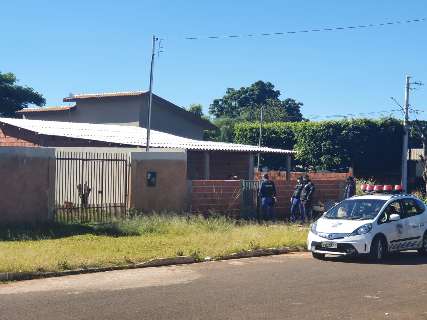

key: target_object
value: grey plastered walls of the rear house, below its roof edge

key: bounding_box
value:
[20,95,211,140]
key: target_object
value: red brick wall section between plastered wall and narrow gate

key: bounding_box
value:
[190,180,240,217]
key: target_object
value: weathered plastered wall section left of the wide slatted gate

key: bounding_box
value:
[0,147,55,224]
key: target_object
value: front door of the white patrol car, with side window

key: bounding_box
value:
[378,200,408,251]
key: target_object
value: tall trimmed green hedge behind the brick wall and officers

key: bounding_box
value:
[235,118,403,176]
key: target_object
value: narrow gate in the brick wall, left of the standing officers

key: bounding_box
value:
[240,180,259,219]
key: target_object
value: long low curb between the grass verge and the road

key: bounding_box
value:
[0,247,306,282]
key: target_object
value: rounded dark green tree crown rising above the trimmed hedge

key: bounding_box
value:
[209,81,303,122]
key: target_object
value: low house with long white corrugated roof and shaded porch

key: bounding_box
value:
[0,118,293,180]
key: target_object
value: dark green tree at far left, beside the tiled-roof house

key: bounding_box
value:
[0,72,46,117]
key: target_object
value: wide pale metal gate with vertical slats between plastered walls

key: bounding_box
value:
[54,151,130,222]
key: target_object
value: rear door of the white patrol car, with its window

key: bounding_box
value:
[401,198,425,249]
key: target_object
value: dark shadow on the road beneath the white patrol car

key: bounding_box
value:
[326,251,427,266]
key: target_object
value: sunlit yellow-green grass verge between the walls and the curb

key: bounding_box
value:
[0,215,307,272]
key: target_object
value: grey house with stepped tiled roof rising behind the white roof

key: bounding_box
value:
[18,91,216,140]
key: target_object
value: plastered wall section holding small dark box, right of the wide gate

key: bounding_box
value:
[130,152,188,212]
